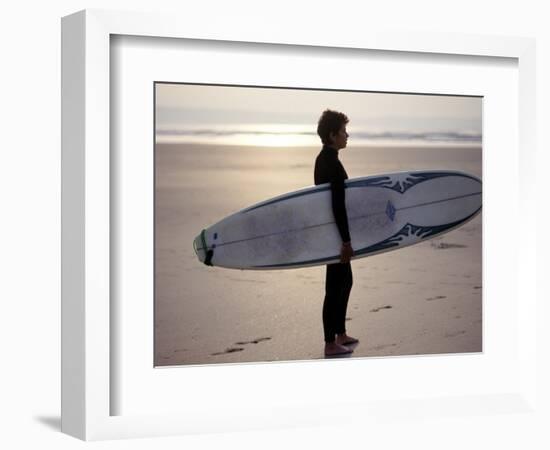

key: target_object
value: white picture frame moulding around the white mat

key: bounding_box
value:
[62,10,537,440]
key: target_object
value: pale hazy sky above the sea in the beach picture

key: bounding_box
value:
[156,84,482,132]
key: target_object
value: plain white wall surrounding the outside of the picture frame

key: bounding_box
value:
[0,0,550,449]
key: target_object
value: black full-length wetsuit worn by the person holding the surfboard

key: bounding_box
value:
[314,145,353,342]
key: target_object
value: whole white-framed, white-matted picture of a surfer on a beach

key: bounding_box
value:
[62,10,536,440]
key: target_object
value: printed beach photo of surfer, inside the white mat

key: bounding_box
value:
[154,82,483,367]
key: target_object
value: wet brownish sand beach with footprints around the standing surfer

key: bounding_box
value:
[154,144,482,366]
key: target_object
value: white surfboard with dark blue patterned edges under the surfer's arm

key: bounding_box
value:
[193,170,482,270]
